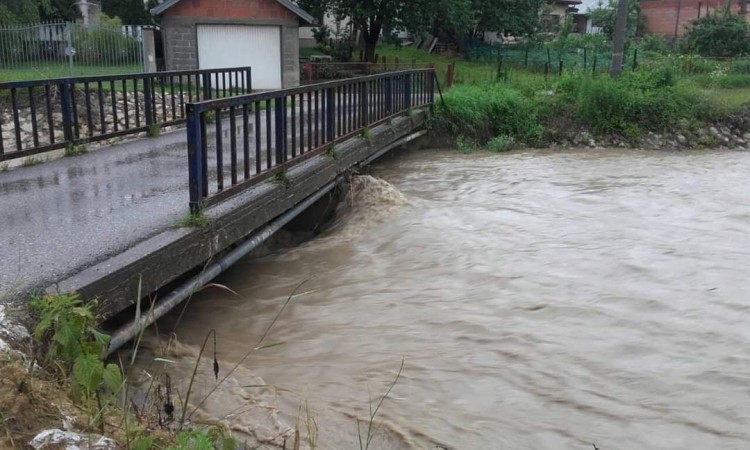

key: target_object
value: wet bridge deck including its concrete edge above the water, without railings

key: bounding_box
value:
[0,110,426,317]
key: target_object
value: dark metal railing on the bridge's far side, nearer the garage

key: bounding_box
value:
[0,67,252,162]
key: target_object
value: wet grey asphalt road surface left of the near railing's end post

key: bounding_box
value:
[0,130,188,300]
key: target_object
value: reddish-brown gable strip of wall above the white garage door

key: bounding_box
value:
[165,0,296,19]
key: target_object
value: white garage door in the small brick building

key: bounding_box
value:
[198,25,281,89]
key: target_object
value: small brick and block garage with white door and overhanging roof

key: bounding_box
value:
[151,0,315,90]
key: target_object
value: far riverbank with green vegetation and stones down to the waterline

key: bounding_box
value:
[432,66,750,151]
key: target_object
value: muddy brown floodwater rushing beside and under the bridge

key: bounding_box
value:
[134,150,750,450]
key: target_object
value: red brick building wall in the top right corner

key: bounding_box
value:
[641,0,739,36]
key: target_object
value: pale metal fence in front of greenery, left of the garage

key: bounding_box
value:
[0,23,143,81]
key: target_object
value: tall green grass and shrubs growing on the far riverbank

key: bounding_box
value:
[432,65,750,147]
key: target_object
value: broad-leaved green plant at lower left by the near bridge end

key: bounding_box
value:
[31,294,122,399]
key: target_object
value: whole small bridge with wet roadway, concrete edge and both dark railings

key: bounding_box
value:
[0,68,437,346]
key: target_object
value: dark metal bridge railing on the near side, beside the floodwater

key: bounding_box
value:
[187,69,435,212]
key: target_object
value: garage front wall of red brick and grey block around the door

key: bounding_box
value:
[161,0,299,88]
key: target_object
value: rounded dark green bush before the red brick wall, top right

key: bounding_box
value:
[680,8,750,57]
